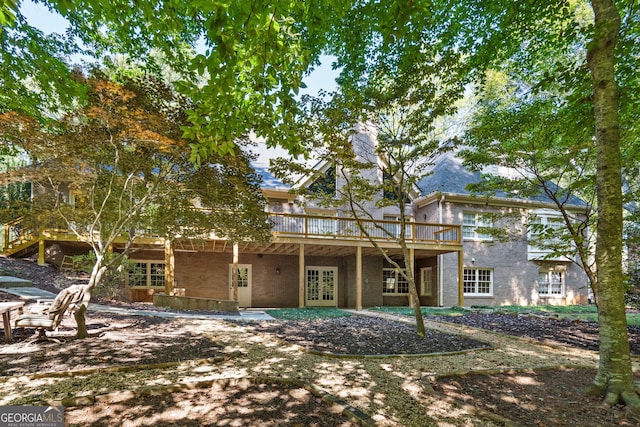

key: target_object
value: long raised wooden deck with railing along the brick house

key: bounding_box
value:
[3,213,462,256]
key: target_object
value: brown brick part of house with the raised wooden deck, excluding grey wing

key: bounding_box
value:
[4,136,463,308]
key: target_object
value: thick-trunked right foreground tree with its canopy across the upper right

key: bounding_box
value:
[322,0,640,409]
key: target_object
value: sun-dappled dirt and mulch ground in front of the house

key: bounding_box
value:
[0,257,640,427]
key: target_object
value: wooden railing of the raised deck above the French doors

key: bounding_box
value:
[269,213,461,245]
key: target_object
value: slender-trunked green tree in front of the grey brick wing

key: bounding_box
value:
[459,72,597,298]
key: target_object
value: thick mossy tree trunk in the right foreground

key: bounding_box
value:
[587,0,640,409]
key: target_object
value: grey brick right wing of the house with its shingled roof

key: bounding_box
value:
[415,154,589,306]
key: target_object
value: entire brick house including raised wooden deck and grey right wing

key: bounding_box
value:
[4,135,587,309]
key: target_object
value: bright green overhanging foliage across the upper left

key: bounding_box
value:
[0,0,344,157]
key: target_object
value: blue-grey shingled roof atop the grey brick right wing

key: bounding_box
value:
[418,153,588,207]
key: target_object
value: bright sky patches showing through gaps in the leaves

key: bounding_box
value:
[20,0,338,95]
